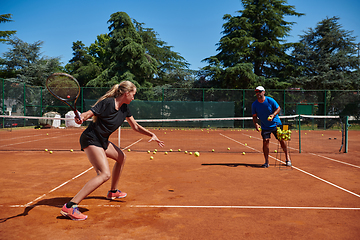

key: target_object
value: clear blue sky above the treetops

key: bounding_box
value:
[0,0,360,70]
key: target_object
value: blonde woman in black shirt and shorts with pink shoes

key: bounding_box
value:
[60,81,164,220]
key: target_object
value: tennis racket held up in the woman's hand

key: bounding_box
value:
[46,73,81,120]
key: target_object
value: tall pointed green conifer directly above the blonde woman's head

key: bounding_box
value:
[87,12,158,87]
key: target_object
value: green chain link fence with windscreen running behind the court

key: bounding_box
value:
[0,79,360,121]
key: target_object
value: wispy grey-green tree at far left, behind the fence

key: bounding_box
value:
[2,37,63,86]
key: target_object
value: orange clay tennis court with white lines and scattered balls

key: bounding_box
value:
[0,128,360,239]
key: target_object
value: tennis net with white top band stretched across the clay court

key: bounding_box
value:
[0,115,347,153]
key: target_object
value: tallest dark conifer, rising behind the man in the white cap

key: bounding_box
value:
[203,0,303,88]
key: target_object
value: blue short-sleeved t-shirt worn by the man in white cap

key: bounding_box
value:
[251,97,281,130]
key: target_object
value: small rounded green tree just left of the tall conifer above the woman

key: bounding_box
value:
[65,41,101,87]
